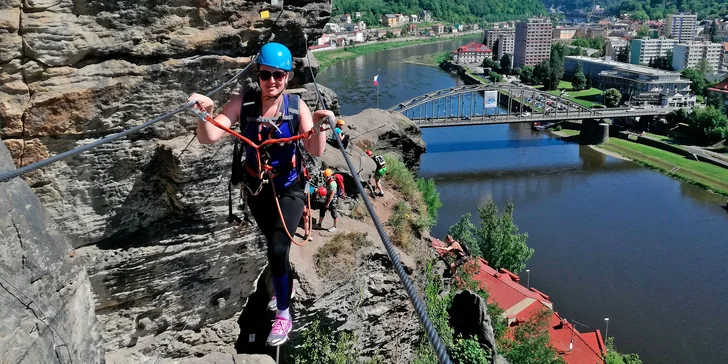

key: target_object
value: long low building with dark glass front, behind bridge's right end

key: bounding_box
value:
[564,56,694,105]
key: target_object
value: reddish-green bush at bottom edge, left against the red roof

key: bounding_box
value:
[498,309,565,364]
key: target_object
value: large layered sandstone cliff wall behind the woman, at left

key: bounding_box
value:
[0,0,336,363]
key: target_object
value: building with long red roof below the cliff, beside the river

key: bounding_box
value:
[432,239,607,364]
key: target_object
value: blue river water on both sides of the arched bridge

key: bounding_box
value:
[318,37,728,364]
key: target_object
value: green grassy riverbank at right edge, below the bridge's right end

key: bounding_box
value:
[551,129,728,196]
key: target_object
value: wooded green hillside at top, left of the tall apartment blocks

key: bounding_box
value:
[333,0,546,25]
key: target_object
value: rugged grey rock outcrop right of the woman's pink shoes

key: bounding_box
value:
[293,247,420,363]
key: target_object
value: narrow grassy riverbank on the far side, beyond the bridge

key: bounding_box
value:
[313,32,482,72]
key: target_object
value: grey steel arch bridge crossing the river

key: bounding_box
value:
[389,85,680,128]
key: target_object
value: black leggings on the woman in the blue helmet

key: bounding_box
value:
[248,183,306,279]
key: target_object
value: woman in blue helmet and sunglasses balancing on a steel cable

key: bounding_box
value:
[189,43,334,346]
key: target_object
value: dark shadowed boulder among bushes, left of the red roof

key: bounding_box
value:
[449,291,497,357]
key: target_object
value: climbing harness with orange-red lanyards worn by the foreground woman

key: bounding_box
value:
[190,101,333,246]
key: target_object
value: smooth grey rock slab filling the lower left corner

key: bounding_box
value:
[0,145,104,364]
